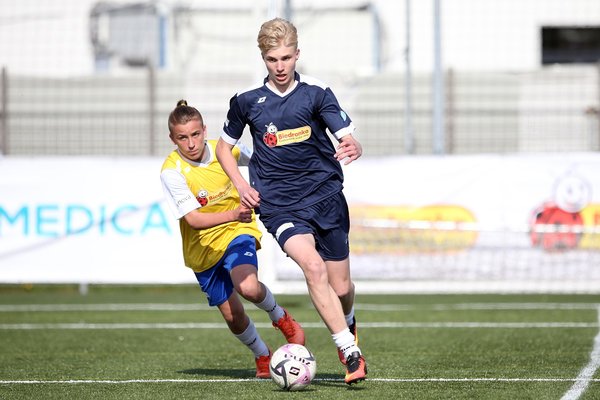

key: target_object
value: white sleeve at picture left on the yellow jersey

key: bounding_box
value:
[160,169,201,219]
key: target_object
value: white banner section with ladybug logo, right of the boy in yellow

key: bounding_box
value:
[273,153,600,292]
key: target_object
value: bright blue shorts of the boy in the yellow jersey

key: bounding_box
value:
[196,235,258,306]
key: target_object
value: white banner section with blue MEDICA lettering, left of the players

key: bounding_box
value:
[0,157,190,283]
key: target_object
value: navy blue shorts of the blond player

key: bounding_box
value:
[260,192,350,261]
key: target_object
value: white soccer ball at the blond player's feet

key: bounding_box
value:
[269,343,317,391]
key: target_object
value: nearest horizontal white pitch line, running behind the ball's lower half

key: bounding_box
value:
[0,378,600,385]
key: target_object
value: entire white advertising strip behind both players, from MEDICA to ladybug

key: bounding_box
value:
[0,153,600,292]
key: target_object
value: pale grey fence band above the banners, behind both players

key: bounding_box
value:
[0,66,600,156]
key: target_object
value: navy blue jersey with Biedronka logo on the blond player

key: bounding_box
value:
[221,73,354,212]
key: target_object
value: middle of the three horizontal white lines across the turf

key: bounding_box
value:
[0,322,600,330]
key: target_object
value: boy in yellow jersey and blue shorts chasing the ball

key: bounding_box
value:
[160,100,304,378]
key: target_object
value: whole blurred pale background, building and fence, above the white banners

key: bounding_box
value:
[0,0,600,156]
